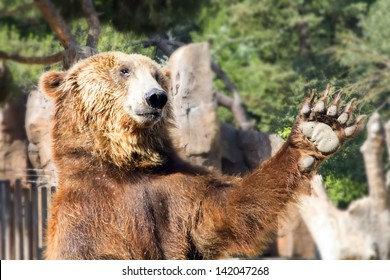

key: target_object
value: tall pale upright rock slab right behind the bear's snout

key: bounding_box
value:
[169,43,221,170]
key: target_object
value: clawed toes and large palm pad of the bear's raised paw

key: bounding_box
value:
[298,86,366,156]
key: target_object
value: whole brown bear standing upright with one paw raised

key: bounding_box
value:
[40,52,364,259]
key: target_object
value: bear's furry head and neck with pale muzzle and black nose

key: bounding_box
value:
[40,52,172,169]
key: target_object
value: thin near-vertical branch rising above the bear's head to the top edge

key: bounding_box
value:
[82,0,100,49]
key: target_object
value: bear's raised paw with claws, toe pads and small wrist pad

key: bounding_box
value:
[291,86,366,170]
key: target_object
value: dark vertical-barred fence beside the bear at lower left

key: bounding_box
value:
[0,180,56,260]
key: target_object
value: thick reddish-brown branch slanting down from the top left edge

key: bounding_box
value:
[34,0,77,49]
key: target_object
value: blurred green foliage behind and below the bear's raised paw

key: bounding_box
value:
[193,0,390,206]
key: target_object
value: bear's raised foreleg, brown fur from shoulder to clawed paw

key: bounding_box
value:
[192,88,365,258]
